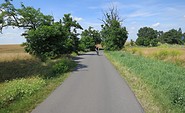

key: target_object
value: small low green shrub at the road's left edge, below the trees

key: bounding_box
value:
[52,59,76,75]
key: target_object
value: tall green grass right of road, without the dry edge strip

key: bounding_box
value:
[107,51,185,113]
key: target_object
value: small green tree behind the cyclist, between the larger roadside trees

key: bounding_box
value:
[80,27,101,51]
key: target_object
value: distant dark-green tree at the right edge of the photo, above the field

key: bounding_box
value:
[160,29,183,44]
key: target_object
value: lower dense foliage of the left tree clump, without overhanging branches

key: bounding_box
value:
[24,14,81,61]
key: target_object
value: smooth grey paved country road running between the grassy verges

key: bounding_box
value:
[32,52,144,113]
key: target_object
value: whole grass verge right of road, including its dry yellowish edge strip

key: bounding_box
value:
[106,51,185,113]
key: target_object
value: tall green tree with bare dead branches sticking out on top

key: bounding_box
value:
[101,7,128,50]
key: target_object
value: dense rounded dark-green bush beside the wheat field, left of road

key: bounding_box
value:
[24,24,68,61]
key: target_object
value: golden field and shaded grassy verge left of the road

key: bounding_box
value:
[0,45,75,113]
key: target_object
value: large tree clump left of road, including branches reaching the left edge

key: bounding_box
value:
[0,1,82,61]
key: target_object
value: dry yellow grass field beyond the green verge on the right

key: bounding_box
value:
[126,47,185,67]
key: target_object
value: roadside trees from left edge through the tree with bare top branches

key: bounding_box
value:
[0,0,128,61]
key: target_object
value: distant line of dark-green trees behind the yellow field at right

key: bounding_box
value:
[136,27,185,46]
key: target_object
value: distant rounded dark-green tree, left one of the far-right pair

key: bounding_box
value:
[136,27,159,46]
